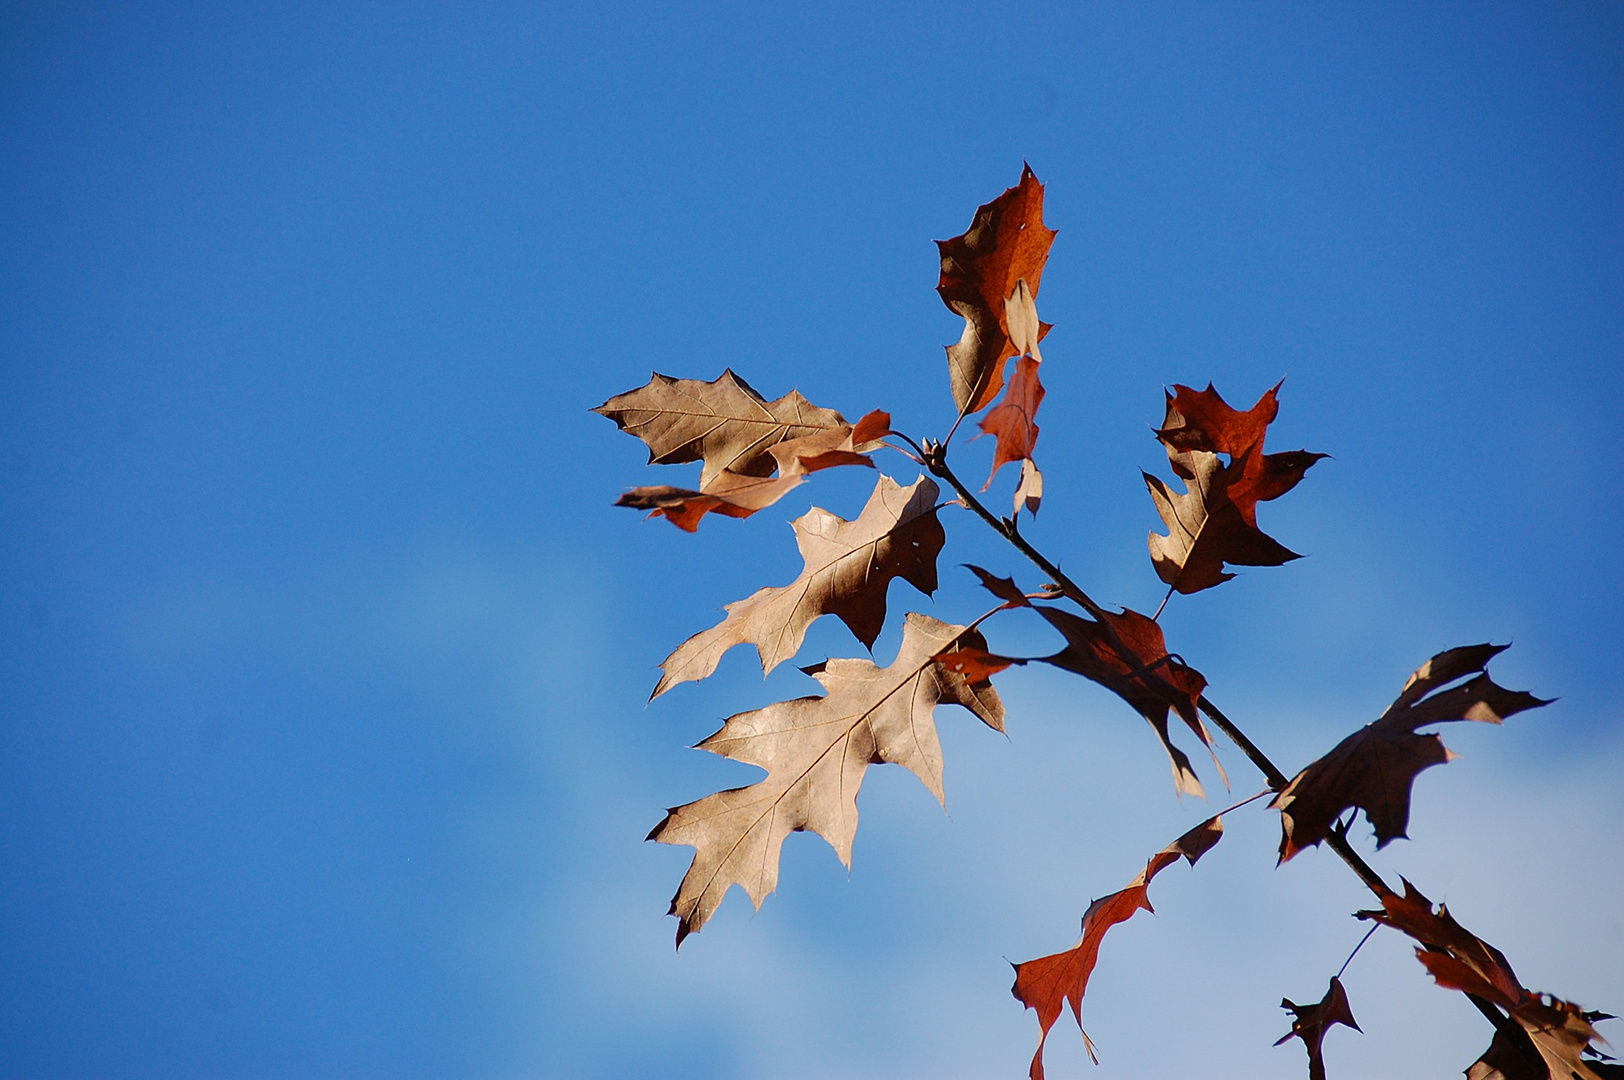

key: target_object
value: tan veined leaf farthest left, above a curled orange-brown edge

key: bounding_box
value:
[593,370,849,490]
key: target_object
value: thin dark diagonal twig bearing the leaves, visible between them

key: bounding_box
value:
[922,435,1544,1069]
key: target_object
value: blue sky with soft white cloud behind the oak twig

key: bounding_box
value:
[0,3,1624,1080]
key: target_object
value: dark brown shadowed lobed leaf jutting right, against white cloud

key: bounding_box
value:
[1270,645,1549,862]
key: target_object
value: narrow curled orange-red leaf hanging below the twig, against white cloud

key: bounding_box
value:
[1010,817,1223,1080]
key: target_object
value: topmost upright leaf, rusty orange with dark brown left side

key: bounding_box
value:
[935,166,1054,414]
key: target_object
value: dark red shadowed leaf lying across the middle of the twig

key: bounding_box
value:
[1038,607,1229,797]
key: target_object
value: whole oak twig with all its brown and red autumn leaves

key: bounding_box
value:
[598,169,1624,1080]
